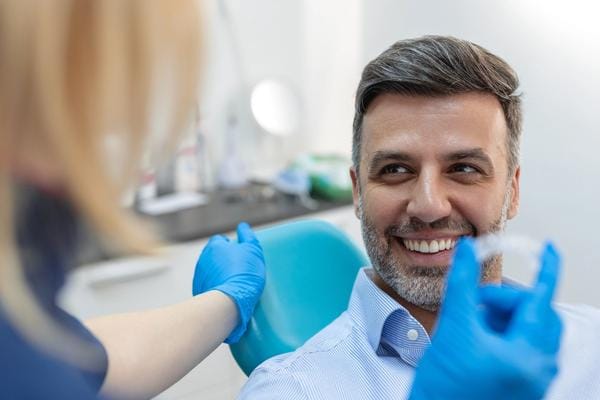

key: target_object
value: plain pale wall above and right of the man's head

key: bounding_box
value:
[362,0,600,306]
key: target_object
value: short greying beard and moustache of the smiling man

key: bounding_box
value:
[358,190,510,312]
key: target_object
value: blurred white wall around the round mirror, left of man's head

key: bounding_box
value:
[201,0,362,181]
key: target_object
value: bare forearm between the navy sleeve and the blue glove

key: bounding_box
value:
[86,291,238,399]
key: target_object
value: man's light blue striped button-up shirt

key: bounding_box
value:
[239,269,600,400]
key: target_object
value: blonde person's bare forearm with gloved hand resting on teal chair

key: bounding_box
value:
[86,223,265,399]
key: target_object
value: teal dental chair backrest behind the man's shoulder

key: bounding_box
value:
[231,220,369,375]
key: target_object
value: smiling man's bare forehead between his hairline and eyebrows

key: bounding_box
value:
[362,93,507,157]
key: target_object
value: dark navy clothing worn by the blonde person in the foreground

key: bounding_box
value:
[0,184,108,399]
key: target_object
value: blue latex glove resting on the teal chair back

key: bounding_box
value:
[192,222,265,343]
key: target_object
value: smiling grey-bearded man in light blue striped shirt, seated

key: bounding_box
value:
[241,36,600,400]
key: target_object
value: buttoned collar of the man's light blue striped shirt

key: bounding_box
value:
[348,268,430,366]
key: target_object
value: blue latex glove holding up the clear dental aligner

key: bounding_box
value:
[409,239,562,400]
